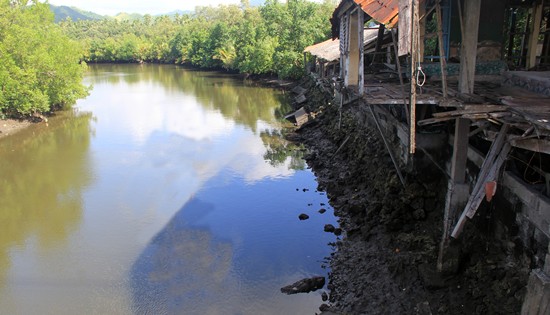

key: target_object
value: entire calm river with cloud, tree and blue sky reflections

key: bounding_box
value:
[0,65,336,315]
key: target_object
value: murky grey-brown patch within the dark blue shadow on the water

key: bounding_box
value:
[131,199,233,314]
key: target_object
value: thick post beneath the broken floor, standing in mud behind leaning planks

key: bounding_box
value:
[437,118,470,272]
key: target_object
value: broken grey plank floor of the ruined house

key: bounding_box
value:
[363,72,550,154]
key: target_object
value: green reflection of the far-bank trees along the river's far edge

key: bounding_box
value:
[87,64,290,131]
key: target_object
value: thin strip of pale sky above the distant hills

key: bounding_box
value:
[45,0,248,15]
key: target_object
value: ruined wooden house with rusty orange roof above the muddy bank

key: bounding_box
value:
[331,0,550,314]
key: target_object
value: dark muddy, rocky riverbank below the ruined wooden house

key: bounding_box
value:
[287,77,531,314]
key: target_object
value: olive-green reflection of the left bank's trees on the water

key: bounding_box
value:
[0,111,92,285]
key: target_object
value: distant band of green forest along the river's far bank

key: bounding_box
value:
[60,0,337,78]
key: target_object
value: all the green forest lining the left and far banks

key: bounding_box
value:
[0,0,337,118]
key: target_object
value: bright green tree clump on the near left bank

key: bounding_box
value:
[0,0,87,118]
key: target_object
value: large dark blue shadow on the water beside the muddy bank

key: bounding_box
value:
[130,171,335,315]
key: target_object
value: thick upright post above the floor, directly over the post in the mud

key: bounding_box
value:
[458,0,481,94]
